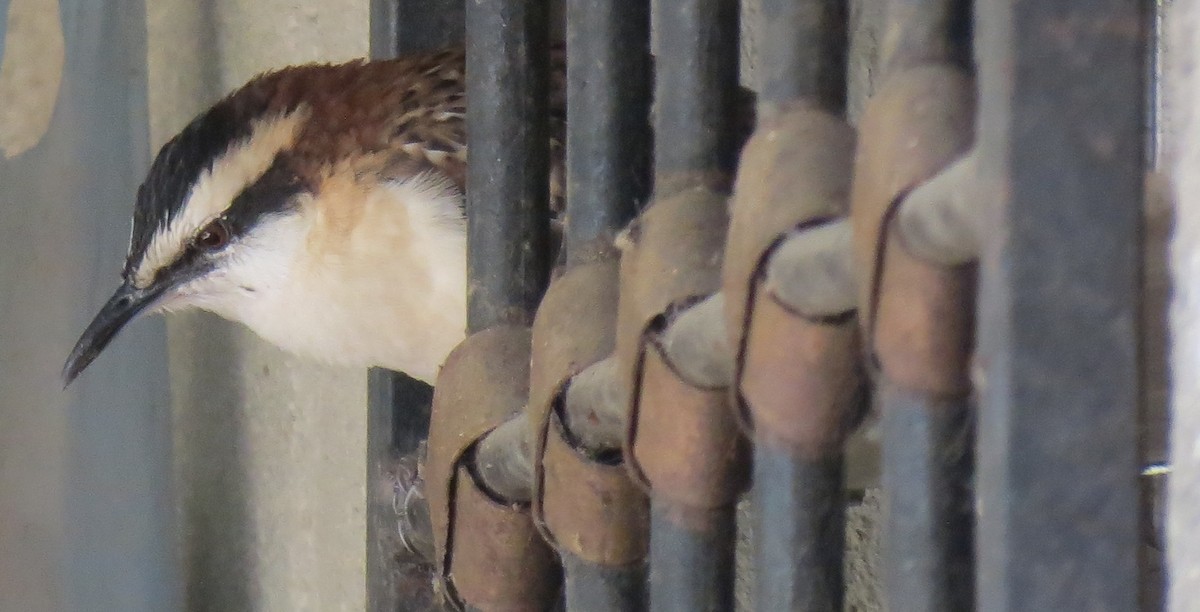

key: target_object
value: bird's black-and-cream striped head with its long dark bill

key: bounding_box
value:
[62,76,310,384]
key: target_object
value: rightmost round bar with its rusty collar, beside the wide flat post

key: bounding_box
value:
[852,0,974,611]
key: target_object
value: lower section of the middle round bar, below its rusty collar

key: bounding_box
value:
[650,498,737,612]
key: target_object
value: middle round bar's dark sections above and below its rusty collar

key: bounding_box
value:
[650,0,739,611]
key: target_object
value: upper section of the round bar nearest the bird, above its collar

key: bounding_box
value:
[466,0,550,332]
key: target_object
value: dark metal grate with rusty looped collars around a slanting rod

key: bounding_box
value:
[368,0,1150,611]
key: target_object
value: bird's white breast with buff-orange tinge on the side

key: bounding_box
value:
[202,171,467,383]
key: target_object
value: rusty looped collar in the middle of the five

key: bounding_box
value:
[617,188,746,511]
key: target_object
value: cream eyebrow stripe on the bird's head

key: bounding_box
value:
[133,107,308,287]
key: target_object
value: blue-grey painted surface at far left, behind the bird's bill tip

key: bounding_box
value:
[0,0,178,611]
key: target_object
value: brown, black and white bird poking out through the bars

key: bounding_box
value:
[61,46,565,385]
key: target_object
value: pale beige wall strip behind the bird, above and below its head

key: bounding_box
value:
[148,0,367,611]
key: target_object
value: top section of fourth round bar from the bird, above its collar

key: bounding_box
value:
[757,0,850,115]
